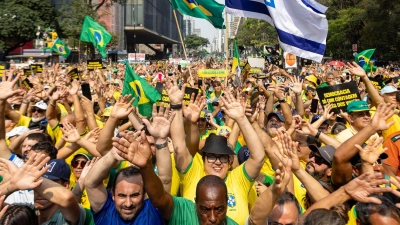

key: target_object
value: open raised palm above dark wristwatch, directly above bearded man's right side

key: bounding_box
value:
[143,104,175,139]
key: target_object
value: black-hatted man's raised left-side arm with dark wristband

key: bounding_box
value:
[165,77,192,172]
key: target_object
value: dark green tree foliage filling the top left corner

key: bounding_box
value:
[0,0,55,55]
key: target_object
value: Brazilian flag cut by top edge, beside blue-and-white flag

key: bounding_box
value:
[171,0,225,29]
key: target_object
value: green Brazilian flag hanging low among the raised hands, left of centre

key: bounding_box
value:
[122,63,161,116]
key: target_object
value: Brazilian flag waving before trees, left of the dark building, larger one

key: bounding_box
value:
[80,16,112,58]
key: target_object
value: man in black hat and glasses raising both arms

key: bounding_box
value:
[166,84,264,224]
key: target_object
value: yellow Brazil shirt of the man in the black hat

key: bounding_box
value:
[179,154,254,224]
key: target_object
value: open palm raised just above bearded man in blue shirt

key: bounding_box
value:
[112,131,152,168]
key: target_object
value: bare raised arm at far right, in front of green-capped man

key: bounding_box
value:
[332,103,394,185]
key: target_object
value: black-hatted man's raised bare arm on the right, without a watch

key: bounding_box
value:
[220,92,265,179]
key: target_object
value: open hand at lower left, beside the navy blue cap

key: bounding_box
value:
[8,153,50,190]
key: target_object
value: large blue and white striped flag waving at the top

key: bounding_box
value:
[225,0,328,62]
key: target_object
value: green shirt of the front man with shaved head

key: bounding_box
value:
[168,196,238,225]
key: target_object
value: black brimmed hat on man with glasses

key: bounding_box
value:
[201,134,235,155]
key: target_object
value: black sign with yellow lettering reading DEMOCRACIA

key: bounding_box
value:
[317,81,360,114]
